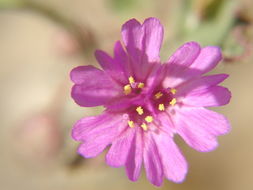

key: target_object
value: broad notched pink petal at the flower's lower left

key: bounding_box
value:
[72,113,127,158]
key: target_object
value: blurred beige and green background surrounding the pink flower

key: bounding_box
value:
[0,0,253,190]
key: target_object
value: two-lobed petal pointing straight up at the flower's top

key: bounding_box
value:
[122,18,163,81]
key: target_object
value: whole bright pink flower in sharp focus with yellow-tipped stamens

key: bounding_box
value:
[71,18,231,186]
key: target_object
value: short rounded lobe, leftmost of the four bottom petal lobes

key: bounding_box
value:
[106,128,135,167]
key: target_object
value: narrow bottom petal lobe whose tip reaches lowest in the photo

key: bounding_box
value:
[143,133,163,186]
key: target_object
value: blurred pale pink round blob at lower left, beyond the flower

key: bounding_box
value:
[16,113,63,165]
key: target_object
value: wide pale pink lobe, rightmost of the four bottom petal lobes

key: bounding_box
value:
[154,132,188,183]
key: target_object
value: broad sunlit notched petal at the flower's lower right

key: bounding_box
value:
[174,108,230,152]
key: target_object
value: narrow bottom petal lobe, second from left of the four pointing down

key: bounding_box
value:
[125,128,143,181]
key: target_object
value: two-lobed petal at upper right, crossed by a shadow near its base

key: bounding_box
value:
[163,42,222,87]
